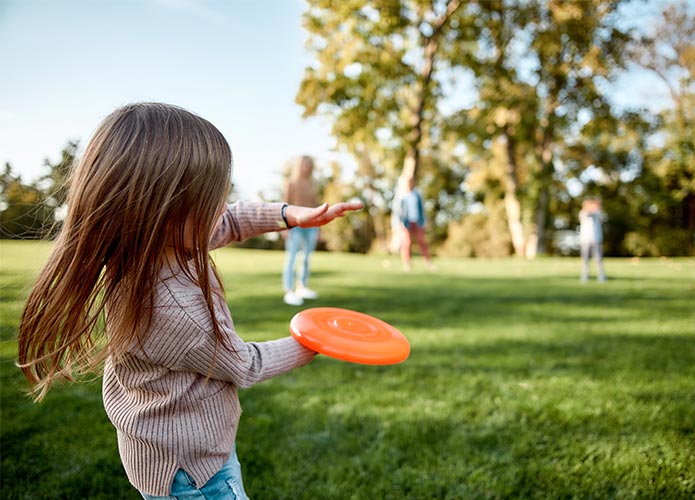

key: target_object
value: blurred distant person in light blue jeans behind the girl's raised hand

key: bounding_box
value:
[282,156,319,306]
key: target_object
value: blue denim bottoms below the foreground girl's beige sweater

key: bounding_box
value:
[140,447,249,500]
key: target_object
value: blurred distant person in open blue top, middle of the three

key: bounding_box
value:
[393,177,434,271]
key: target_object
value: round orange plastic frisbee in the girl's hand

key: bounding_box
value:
[290,307,410,365]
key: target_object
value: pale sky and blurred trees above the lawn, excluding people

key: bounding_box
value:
[0,0,695,257]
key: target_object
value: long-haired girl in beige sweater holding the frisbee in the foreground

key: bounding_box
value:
[18,103,361,498]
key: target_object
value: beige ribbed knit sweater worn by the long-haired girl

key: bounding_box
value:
[103,203,315,496]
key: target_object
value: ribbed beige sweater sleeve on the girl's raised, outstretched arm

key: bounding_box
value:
[209,201,284,250]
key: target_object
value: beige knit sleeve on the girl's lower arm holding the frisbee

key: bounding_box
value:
[143,286,316,388]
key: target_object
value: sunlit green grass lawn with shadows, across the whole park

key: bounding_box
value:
[0,242,695,499]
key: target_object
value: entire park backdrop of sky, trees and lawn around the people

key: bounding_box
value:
[0,0,695,498]
